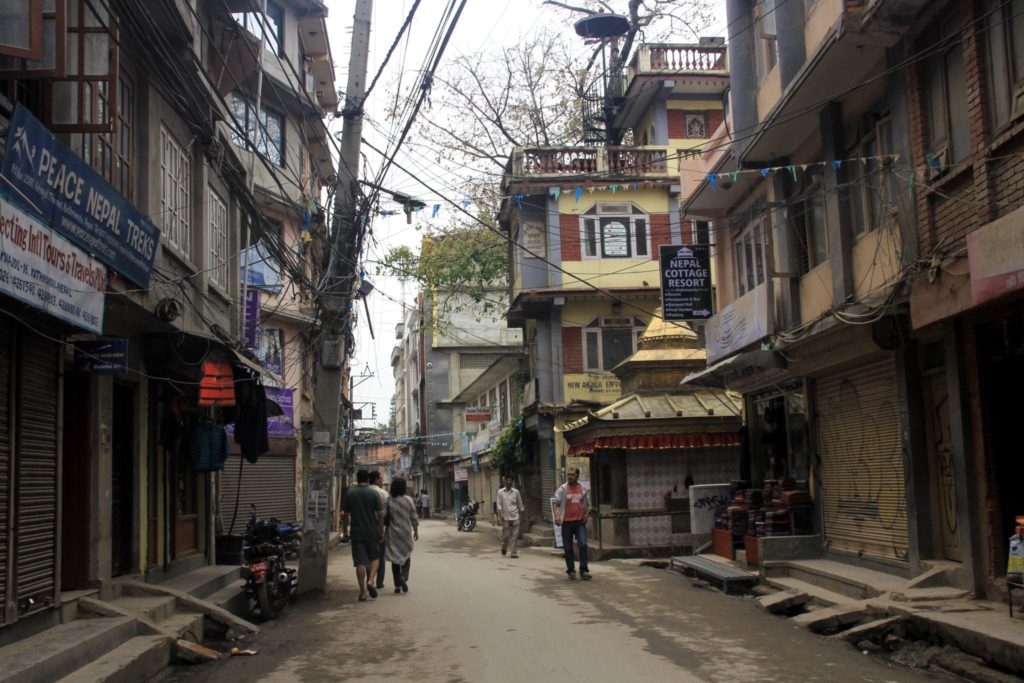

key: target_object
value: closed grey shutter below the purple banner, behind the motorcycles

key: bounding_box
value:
[220,454,296,533]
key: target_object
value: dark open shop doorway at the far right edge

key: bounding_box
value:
[979,316,1024,575]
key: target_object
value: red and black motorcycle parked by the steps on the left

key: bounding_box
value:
[243,504,298,621]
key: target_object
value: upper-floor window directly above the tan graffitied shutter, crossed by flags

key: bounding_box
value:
[847,101,896,234]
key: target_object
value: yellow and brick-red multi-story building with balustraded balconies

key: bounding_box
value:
[501,39,729,519]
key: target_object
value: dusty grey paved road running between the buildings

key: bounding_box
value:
[163,519,936,683]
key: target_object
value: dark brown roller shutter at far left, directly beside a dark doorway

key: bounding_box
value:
[14,335,60,615]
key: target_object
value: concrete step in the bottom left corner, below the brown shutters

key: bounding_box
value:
[0,616,136,683]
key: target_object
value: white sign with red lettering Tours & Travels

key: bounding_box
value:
[0,193,106,334]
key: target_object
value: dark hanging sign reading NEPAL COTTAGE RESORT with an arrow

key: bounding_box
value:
[659,245,712,322]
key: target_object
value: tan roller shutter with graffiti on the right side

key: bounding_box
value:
[814,359,907,560]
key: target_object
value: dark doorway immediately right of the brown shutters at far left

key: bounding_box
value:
[60,373,92,591]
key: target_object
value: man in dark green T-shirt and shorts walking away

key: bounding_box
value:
[341,470,384,602]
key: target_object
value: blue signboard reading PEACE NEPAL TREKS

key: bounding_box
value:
[0,105,160,287]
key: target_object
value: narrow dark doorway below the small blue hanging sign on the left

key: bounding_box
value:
[111,384,135,577]
